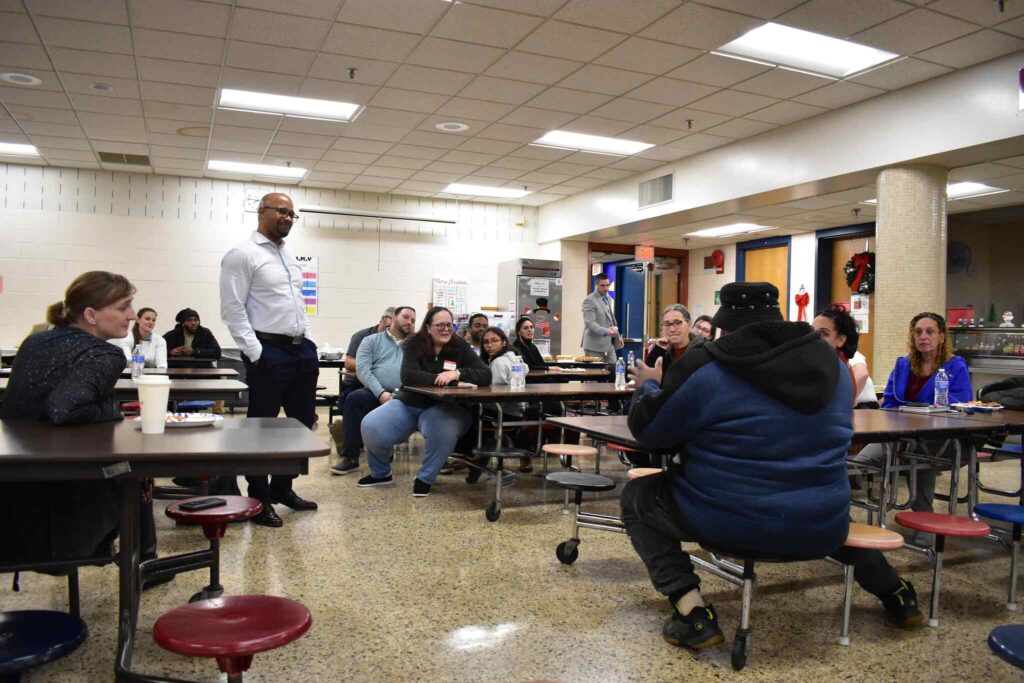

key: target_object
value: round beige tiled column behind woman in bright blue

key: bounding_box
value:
[871,166,947,384]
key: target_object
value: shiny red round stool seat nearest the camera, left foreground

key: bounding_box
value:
[153,595,313,683]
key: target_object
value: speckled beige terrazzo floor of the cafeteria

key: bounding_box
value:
[6,412,1024,683]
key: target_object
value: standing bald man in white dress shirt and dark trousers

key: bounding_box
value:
[220,193,319,526]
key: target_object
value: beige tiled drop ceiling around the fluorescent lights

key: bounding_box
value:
[0,0,1024,205]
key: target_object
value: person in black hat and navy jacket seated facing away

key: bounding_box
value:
[622,283,923,649]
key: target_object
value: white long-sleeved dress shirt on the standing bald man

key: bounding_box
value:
[220,231,312,361]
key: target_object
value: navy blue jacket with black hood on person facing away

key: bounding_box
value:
[630,323,853,559]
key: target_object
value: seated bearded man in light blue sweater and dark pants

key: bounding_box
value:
[331,306,416,475]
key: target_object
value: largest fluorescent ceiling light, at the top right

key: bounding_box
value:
[714,23,899,78]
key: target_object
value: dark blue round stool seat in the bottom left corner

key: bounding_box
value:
[0,609,89,681]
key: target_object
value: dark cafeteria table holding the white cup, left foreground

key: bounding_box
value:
[0,418,331,683]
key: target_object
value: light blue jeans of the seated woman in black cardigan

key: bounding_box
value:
[362,398,472,484]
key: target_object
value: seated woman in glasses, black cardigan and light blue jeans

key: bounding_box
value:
[356,306,490,498]
